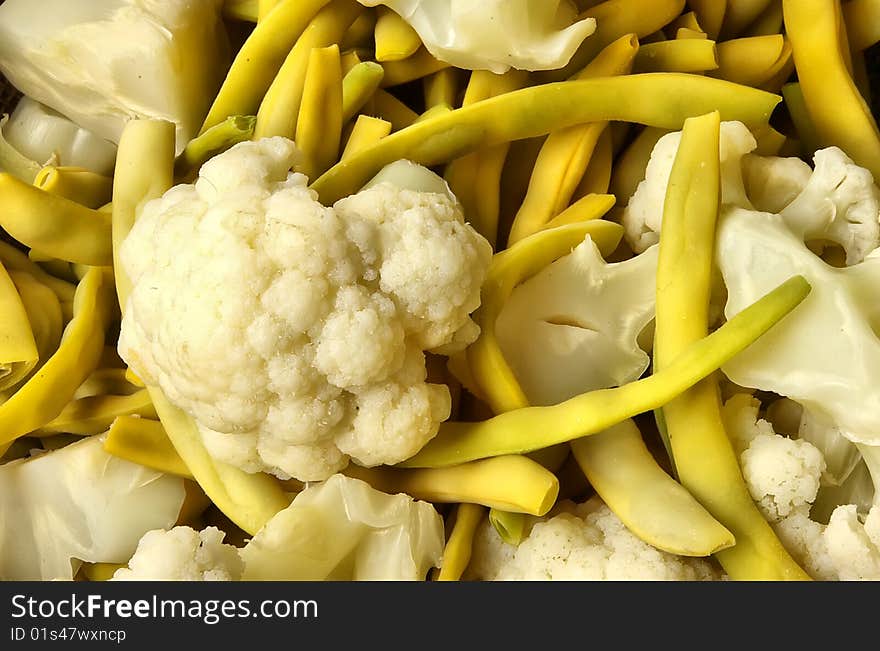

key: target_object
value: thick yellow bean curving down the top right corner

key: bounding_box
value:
[782,0,880,178]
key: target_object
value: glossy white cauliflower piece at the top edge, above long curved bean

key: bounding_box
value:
[359,0,596,74]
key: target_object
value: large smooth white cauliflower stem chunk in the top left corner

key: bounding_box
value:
[0,0,230,152]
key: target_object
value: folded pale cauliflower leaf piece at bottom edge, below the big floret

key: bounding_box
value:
[241,474,444,581]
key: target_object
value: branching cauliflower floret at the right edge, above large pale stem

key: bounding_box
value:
[780,147,880,265]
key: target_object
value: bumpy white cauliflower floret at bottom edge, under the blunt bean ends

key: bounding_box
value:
[468,498,722,581]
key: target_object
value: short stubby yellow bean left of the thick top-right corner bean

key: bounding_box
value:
[709,34,791,86]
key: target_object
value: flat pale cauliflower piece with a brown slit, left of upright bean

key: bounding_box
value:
[495,236,659,405]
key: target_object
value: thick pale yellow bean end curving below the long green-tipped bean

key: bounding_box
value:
[571,419,735,556]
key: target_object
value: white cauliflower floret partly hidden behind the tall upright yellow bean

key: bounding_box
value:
[621,121,757,253]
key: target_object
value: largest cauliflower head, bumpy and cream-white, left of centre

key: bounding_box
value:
[119,138,492,481]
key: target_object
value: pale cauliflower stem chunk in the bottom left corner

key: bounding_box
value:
[0,436,185,581]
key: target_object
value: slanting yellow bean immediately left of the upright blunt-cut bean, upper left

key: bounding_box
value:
[254,0,364,139]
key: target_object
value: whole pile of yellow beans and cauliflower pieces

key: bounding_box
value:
[0,0,880,581]
